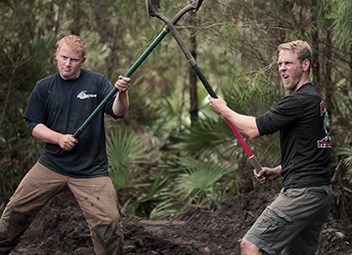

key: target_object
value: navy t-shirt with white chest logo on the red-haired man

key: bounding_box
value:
[24,69,121,178]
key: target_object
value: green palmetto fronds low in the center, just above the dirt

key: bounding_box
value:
[141,158,230,218]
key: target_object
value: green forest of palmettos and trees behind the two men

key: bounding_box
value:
[0,0,352,227]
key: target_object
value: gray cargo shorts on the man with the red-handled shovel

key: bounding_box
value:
[244,186,332,255]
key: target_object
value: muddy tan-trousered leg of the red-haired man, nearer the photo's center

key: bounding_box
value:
[69,177,123,255]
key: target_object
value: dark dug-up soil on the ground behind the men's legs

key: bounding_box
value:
[11,192,352,255]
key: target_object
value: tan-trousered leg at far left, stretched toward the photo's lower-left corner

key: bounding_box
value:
[0,163,63,254]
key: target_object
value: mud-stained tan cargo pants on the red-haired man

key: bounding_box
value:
[0,163,123,255]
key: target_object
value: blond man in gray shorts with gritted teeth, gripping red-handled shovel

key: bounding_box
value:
[210,40,331,255]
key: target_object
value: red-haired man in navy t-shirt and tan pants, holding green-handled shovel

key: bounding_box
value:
[0,35,131,255]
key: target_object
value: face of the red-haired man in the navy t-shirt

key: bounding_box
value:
[56,43,85,80]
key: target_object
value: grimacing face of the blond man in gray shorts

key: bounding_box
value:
[277,50,306,91]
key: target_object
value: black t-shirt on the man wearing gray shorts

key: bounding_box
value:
[256,83,331,188]
